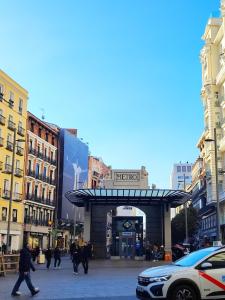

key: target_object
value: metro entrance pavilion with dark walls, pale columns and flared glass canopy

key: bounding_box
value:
[65,189,191,258]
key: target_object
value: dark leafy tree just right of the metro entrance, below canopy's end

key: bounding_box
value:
[171,205,199,243]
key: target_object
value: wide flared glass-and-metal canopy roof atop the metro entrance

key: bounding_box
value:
[65,189,191,207]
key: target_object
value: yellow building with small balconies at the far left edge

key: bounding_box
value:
[0,70,28,250]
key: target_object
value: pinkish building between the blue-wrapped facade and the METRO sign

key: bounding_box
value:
[88,156,111,189]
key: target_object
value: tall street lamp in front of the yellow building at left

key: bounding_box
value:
[6,128,25,253]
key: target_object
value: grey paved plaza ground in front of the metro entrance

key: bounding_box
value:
[0,257,167,300]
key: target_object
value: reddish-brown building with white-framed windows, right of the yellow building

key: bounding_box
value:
[24,112,59,249]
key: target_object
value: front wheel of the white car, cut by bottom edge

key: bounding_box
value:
[170,284,198,300]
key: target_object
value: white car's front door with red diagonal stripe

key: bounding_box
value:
[197,251,225,299]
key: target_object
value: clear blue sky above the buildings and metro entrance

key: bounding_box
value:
[0,0,220,187]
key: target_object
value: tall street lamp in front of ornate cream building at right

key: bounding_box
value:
[205,128,221,241]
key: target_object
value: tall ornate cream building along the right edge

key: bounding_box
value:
[198,0,225,241]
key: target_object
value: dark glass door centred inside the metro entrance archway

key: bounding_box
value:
[119,232,135,259]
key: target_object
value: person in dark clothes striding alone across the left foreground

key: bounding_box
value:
[11,243,40,296]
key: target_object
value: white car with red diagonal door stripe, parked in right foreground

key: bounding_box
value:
[136,247,225,300]
